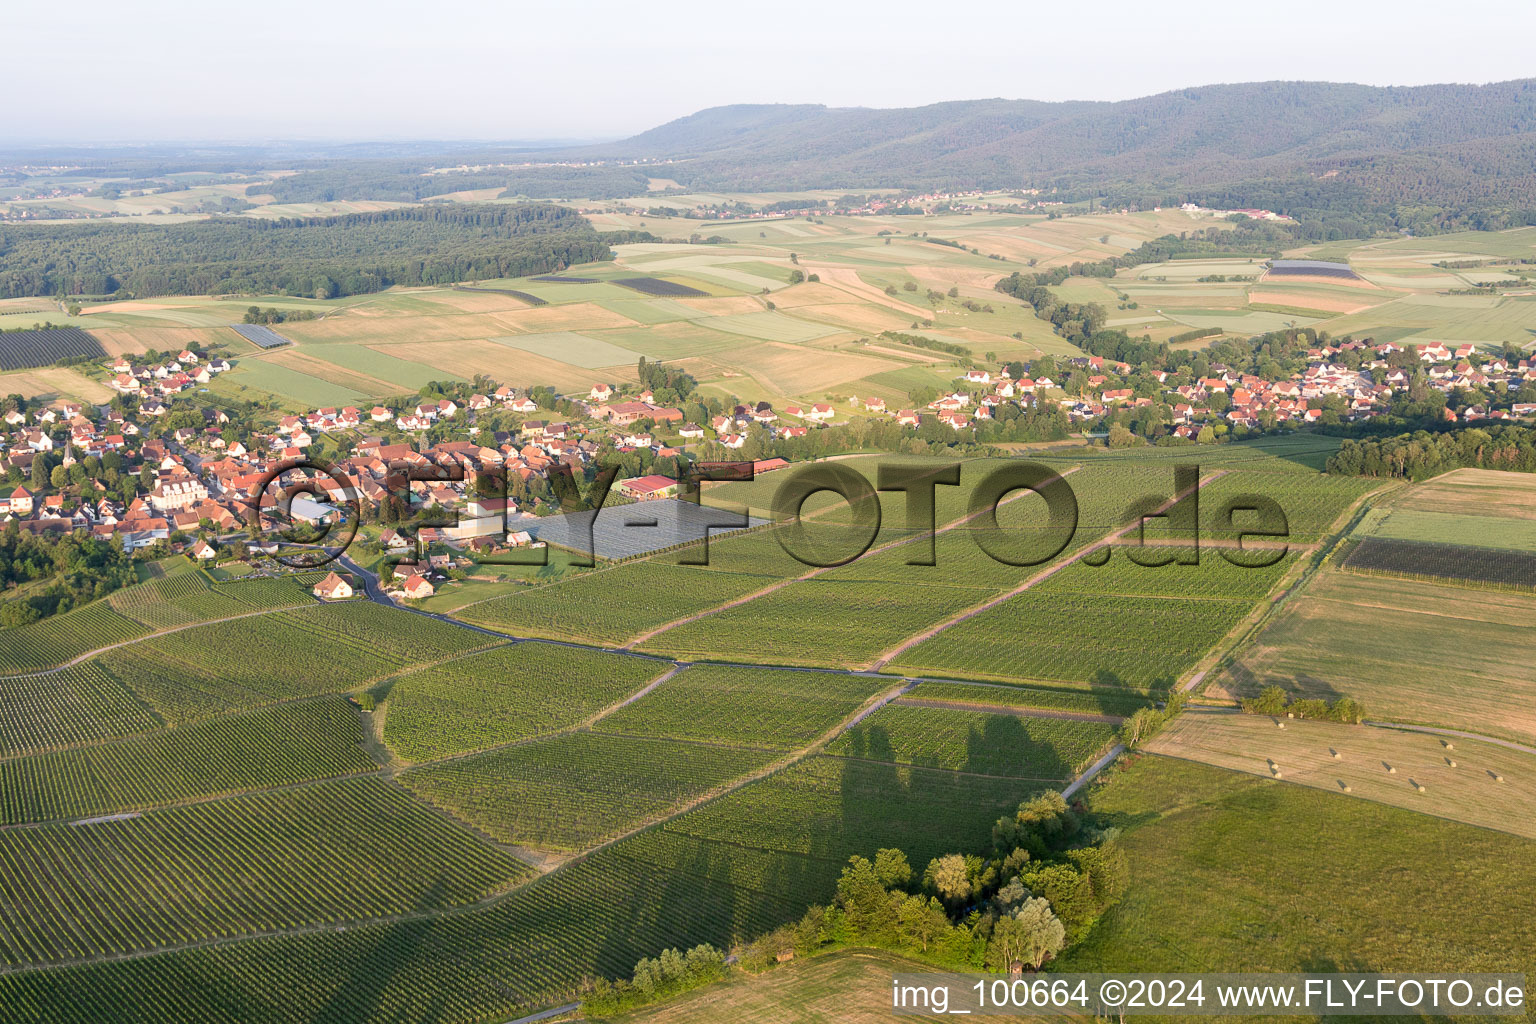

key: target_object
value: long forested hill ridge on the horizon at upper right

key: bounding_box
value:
[581,78,1536,229]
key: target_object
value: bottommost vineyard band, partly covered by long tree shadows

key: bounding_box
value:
[0,758,1028,1024]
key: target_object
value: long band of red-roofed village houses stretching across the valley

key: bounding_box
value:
[0,339,1536,596]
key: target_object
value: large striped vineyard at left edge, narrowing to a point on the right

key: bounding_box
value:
[0,778,528,966]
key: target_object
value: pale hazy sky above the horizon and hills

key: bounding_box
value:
[0,0,1536,144]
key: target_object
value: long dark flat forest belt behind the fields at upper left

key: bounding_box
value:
[0,203,611,298]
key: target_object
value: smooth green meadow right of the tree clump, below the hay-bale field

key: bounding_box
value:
[1052,761,1536,972]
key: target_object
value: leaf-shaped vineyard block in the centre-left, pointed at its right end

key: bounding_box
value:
[384,643,670,761]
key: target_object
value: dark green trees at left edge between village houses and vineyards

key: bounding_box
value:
[0,520,138,628]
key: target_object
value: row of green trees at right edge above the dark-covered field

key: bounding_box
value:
[1326,424,1536,481]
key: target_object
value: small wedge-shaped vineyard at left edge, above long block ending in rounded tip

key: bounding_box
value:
[0,662,161,757]
